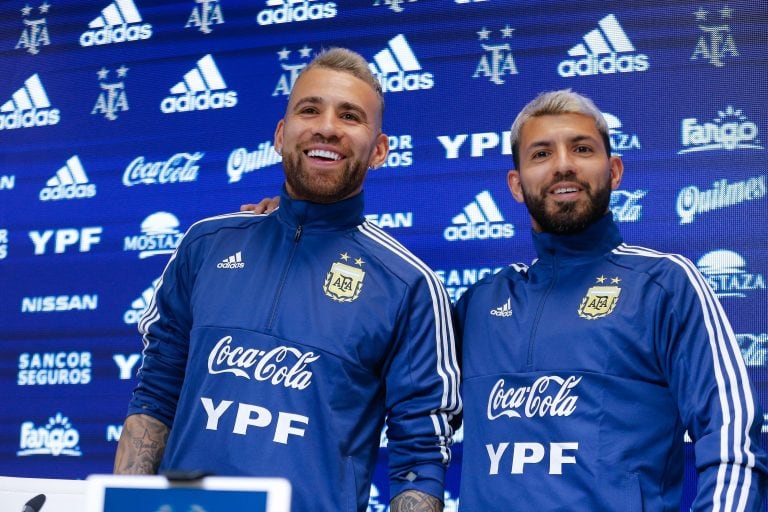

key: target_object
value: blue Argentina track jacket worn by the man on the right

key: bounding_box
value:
[457,215,766,512]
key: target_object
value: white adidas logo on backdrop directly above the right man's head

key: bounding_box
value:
[557,14,649,77]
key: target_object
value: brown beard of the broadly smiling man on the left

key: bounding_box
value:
[283,153,368,204]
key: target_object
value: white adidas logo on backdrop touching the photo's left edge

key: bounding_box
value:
[0,73,61,130]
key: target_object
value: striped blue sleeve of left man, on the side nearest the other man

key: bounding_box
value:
[385,267,461,501]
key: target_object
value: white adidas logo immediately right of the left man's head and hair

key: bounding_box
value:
[368,34,435,92]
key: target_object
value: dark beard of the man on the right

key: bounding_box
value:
[523,177,611,235]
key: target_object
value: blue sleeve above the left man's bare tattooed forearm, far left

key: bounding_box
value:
[128,234,192,428]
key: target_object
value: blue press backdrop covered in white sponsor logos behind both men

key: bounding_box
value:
[0,0,768,511]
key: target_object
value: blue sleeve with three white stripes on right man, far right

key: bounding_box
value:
[656,257,767,511]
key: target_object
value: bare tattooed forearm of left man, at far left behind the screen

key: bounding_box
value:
[114,414,169,475]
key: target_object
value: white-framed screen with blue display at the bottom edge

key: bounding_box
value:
[86,475,291,512]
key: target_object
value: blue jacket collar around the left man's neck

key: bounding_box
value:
[276,185,364,231]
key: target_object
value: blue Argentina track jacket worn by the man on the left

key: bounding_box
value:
[128,192,461,511]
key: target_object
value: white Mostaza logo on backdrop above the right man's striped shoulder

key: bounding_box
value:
[696,249,765,298]
